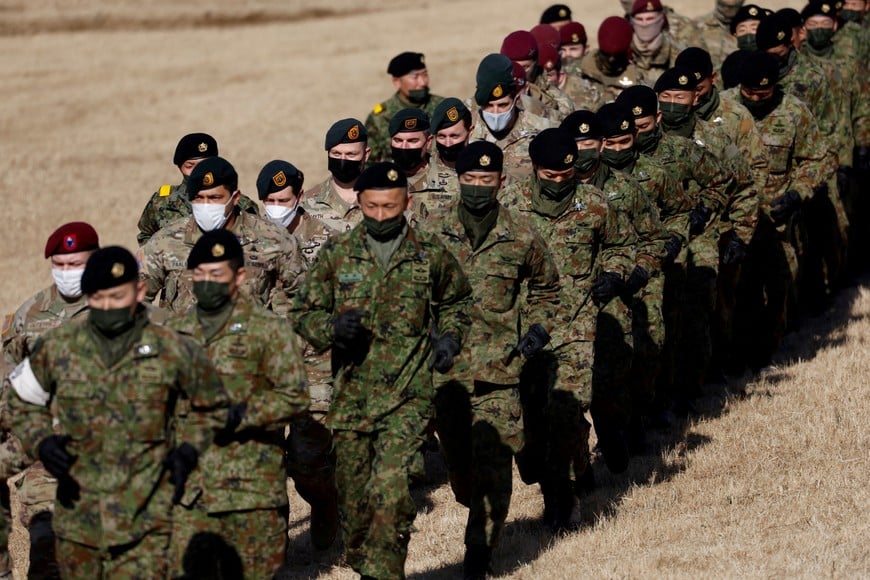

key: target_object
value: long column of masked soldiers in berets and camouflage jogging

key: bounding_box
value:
[0,0,870,578]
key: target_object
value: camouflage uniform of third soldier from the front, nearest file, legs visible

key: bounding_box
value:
[293,226,471,578]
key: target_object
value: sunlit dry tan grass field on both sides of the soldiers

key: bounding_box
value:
[0,0,870,579]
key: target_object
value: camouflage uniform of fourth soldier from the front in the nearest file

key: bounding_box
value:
[432,205,559,549]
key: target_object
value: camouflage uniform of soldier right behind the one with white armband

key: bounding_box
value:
[170,301,308,578]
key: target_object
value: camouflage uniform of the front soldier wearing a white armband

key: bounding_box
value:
[9,307,227,578]
